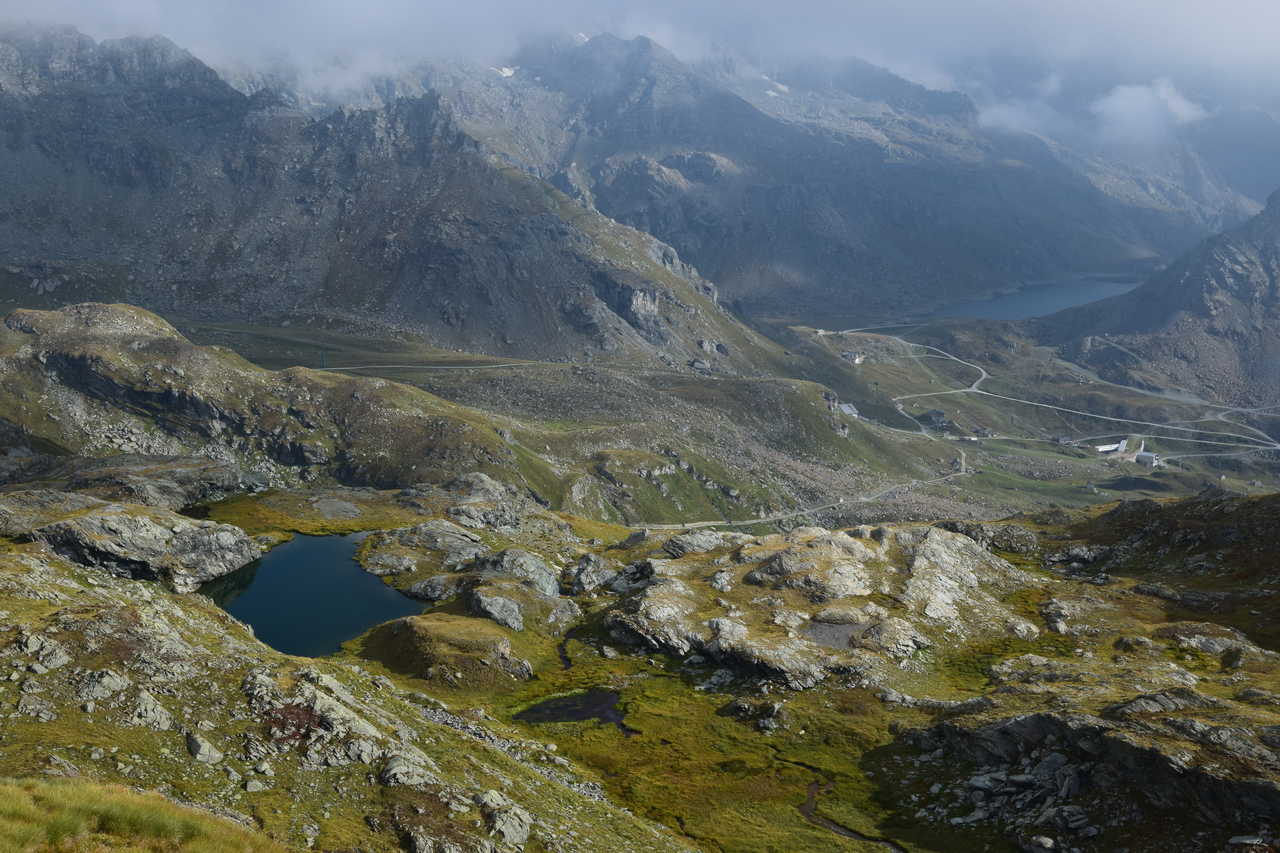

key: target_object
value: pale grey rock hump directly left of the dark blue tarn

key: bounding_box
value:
[24,505,262,592]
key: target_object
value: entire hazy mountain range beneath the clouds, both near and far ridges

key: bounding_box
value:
[0,29,1259,343]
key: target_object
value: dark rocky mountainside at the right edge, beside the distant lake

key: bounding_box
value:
[1034,192,1280,406]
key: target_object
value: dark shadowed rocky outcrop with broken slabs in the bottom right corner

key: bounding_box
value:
[906,712,1280,850]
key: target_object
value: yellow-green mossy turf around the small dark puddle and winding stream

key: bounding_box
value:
[346,596,972,853]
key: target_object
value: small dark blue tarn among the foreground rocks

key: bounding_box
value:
[200,535,422,657]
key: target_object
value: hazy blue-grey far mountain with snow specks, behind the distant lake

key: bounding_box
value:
[420,35,1249,323]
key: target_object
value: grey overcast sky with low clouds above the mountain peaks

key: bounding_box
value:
[0,0,1280,138]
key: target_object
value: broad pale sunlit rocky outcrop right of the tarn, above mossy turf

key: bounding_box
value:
[605,528,1039,689]
